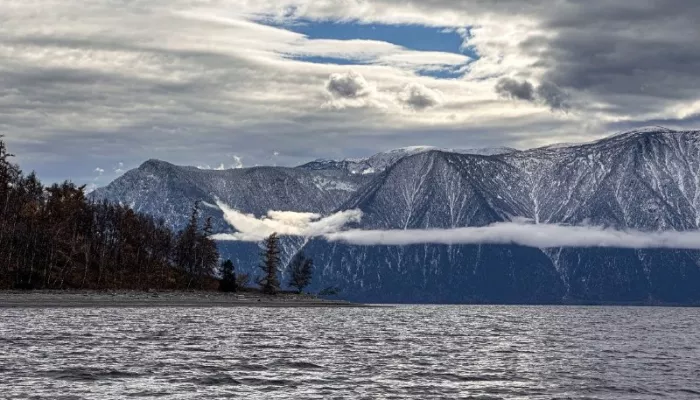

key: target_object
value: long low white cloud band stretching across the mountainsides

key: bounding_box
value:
[213,202,700,250]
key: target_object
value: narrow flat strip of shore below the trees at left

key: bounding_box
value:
[0,291,365,308]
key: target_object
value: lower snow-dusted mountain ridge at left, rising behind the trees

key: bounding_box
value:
[92,160,368,232]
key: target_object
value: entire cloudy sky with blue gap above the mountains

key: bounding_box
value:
[0,0,700,185]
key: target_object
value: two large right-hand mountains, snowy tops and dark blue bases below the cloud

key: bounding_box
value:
[305,129,700,302]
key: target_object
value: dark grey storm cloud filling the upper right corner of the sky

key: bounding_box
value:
[522,0,700,113]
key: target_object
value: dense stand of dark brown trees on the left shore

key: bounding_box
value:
[0,138,219,290]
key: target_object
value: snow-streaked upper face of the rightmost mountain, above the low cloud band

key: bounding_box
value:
[501,129,700,230]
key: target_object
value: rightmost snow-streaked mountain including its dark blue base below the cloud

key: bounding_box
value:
[503,129,700,302]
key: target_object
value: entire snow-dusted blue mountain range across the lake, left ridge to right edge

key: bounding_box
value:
[95,128,700,303]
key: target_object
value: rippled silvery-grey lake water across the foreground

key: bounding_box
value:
[0,306,700,399]
